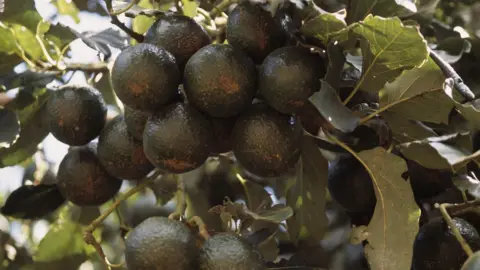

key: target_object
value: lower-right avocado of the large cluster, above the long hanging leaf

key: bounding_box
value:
[232,104,302,177]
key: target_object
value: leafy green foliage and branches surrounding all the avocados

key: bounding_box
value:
[0,0,480,270]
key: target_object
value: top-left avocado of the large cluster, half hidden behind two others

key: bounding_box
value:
[144,14,211,73]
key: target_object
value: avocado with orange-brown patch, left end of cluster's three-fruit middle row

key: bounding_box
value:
[111,43,181,112]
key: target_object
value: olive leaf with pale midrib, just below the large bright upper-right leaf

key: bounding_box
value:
[379,58,454,124]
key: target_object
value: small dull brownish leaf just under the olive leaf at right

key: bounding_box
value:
[381,111,438,143]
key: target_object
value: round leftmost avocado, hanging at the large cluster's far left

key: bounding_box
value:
[46,84,107,146]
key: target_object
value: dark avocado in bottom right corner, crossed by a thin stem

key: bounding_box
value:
[412,217,480,270]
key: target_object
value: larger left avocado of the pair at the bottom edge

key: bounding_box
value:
[125,217,198,270]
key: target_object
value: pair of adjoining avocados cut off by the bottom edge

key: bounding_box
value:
[125,217,266,270]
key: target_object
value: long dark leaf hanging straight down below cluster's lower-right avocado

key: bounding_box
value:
[287,136,328,243]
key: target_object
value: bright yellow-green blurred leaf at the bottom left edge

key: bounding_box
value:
[34,208,87,270]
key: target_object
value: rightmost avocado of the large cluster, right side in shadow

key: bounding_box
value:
[258,46,326,113]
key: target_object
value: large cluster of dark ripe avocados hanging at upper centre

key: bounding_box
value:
[47,2,325,208]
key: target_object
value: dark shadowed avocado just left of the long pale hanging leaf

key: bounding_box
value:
[328,156,377,213]
